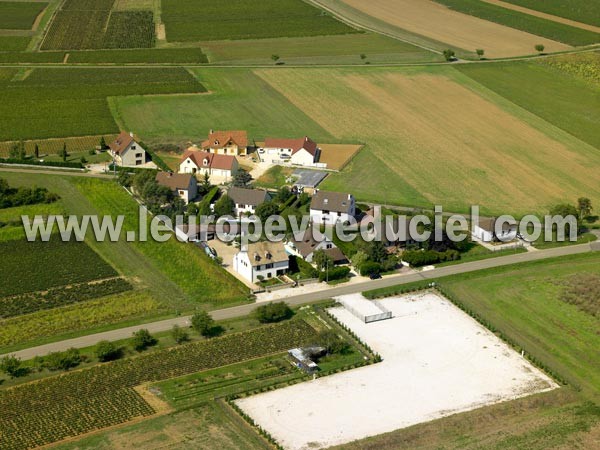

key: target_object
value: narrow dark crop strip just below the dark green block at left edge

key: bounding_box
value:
[0,278,132,319]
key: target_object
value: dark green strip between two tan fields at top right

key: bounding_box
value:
[435,0,600,46]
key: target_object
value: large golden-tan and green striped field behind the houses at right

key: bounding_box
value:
[256,67,600,214]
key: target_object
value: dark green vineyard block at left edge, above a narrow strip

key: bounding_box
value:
[0,235,118,297]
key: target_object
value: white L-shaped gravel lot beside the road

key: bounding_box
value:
[237,293,558,449]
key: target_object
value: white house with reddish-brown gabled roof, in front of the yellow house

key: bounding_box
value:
[179,147,239,181]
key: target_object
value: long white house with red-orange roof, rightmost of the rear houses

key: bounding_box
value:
[259,136,320,166]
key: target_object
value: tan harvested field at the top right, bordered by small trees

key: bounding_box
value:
[342,0,571,58]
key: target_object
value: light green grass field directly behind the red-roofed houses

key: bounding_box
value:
[111,69,332,142]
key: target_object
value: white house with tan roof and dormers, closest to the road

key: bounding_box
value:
[233,241,290,283]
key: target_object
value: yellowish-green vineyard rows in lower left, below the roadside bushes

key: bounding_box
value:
[0,319,316,449]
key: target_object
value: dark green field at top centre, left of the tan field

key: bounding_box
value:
[161,0,357,42]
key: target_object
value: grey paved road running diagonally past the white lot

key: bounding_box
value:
[5,242,600,360]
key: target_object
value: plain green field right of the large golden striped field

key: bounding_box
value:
[455,57,600,149]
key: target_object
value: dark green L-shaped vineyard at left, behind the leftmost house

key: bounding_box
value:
[0,68,205,141]
